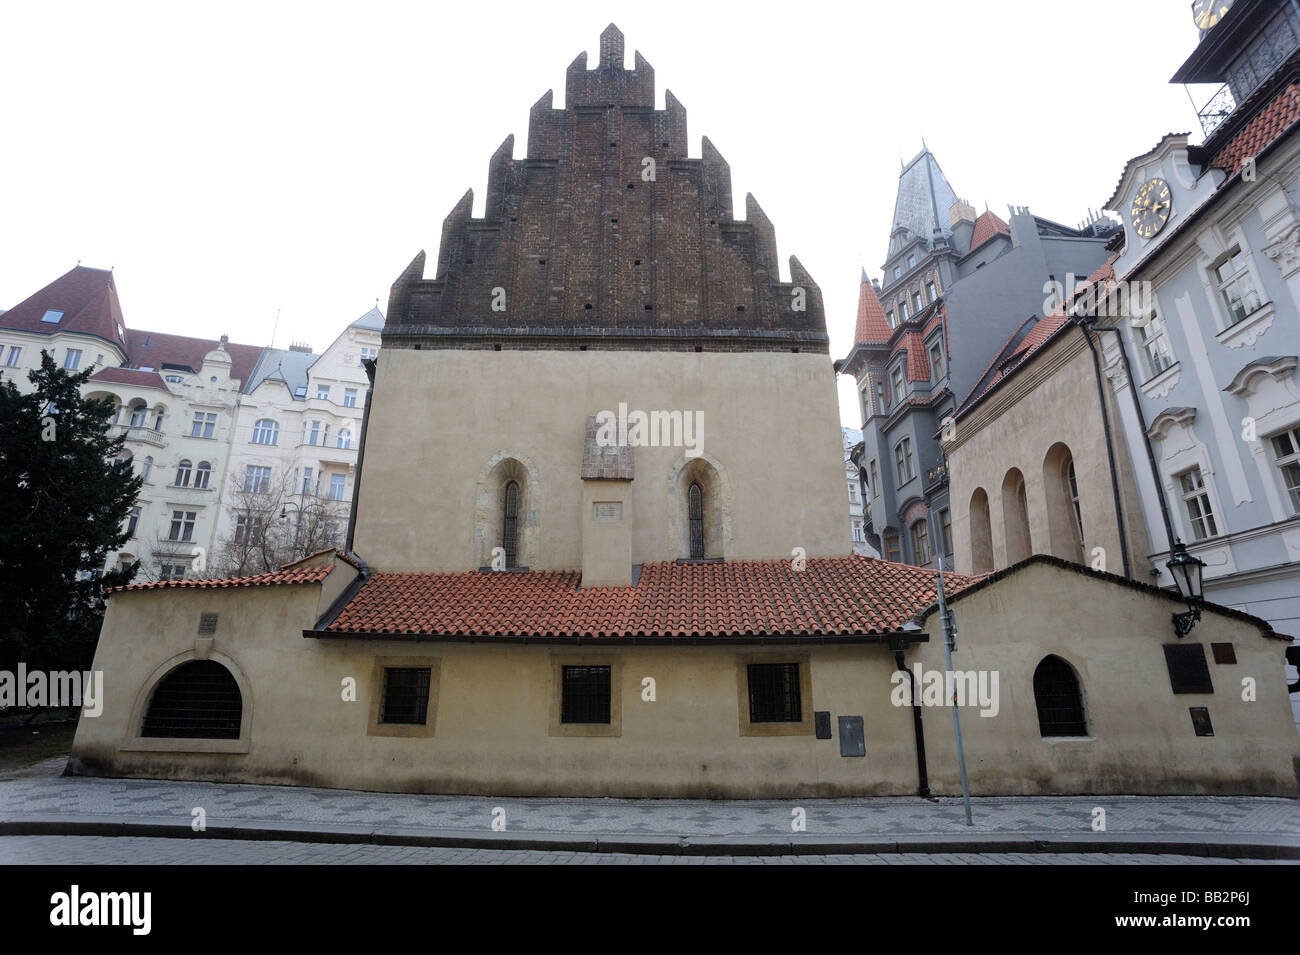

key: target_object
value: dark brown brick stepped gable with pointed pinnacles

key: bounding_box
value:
[384,23,828,353]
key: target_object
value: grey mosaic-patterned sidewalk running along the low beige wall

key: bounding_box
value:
[0,773,1300,839]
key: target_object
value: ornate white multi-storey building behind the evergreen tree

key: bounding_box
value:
[0,265,384,579]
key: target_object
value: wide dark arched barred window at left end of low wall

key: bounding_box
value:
[140,660,243,739]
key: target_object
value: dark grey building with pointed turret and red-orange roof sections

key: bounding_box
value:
[837,149,1117,567]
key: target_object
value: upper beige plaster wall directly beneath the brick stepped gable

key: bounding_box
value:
[355,348,852,570]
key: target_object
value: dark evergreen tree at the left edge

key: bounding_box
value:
[0,350,143,670]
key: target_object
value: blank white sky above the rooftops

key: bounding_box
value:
[0,0,1210,426]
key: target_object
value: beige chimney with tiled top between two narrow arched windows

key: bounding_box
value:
[579,414,633,589]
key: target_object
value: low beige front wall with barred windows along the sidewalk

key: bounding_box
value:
[73,564,1297,798]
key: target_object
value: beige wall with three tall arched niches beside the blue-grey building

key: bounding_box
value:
[944,329,1151,582]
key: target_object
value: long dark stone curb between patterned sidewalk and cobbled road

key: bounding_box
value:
[0,816,1300,860]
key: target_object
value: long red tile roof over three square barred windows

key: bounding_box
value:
[325,556,979,637]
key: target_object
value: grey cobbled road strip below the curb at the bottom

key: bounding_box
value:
[0,835,1296,865]
